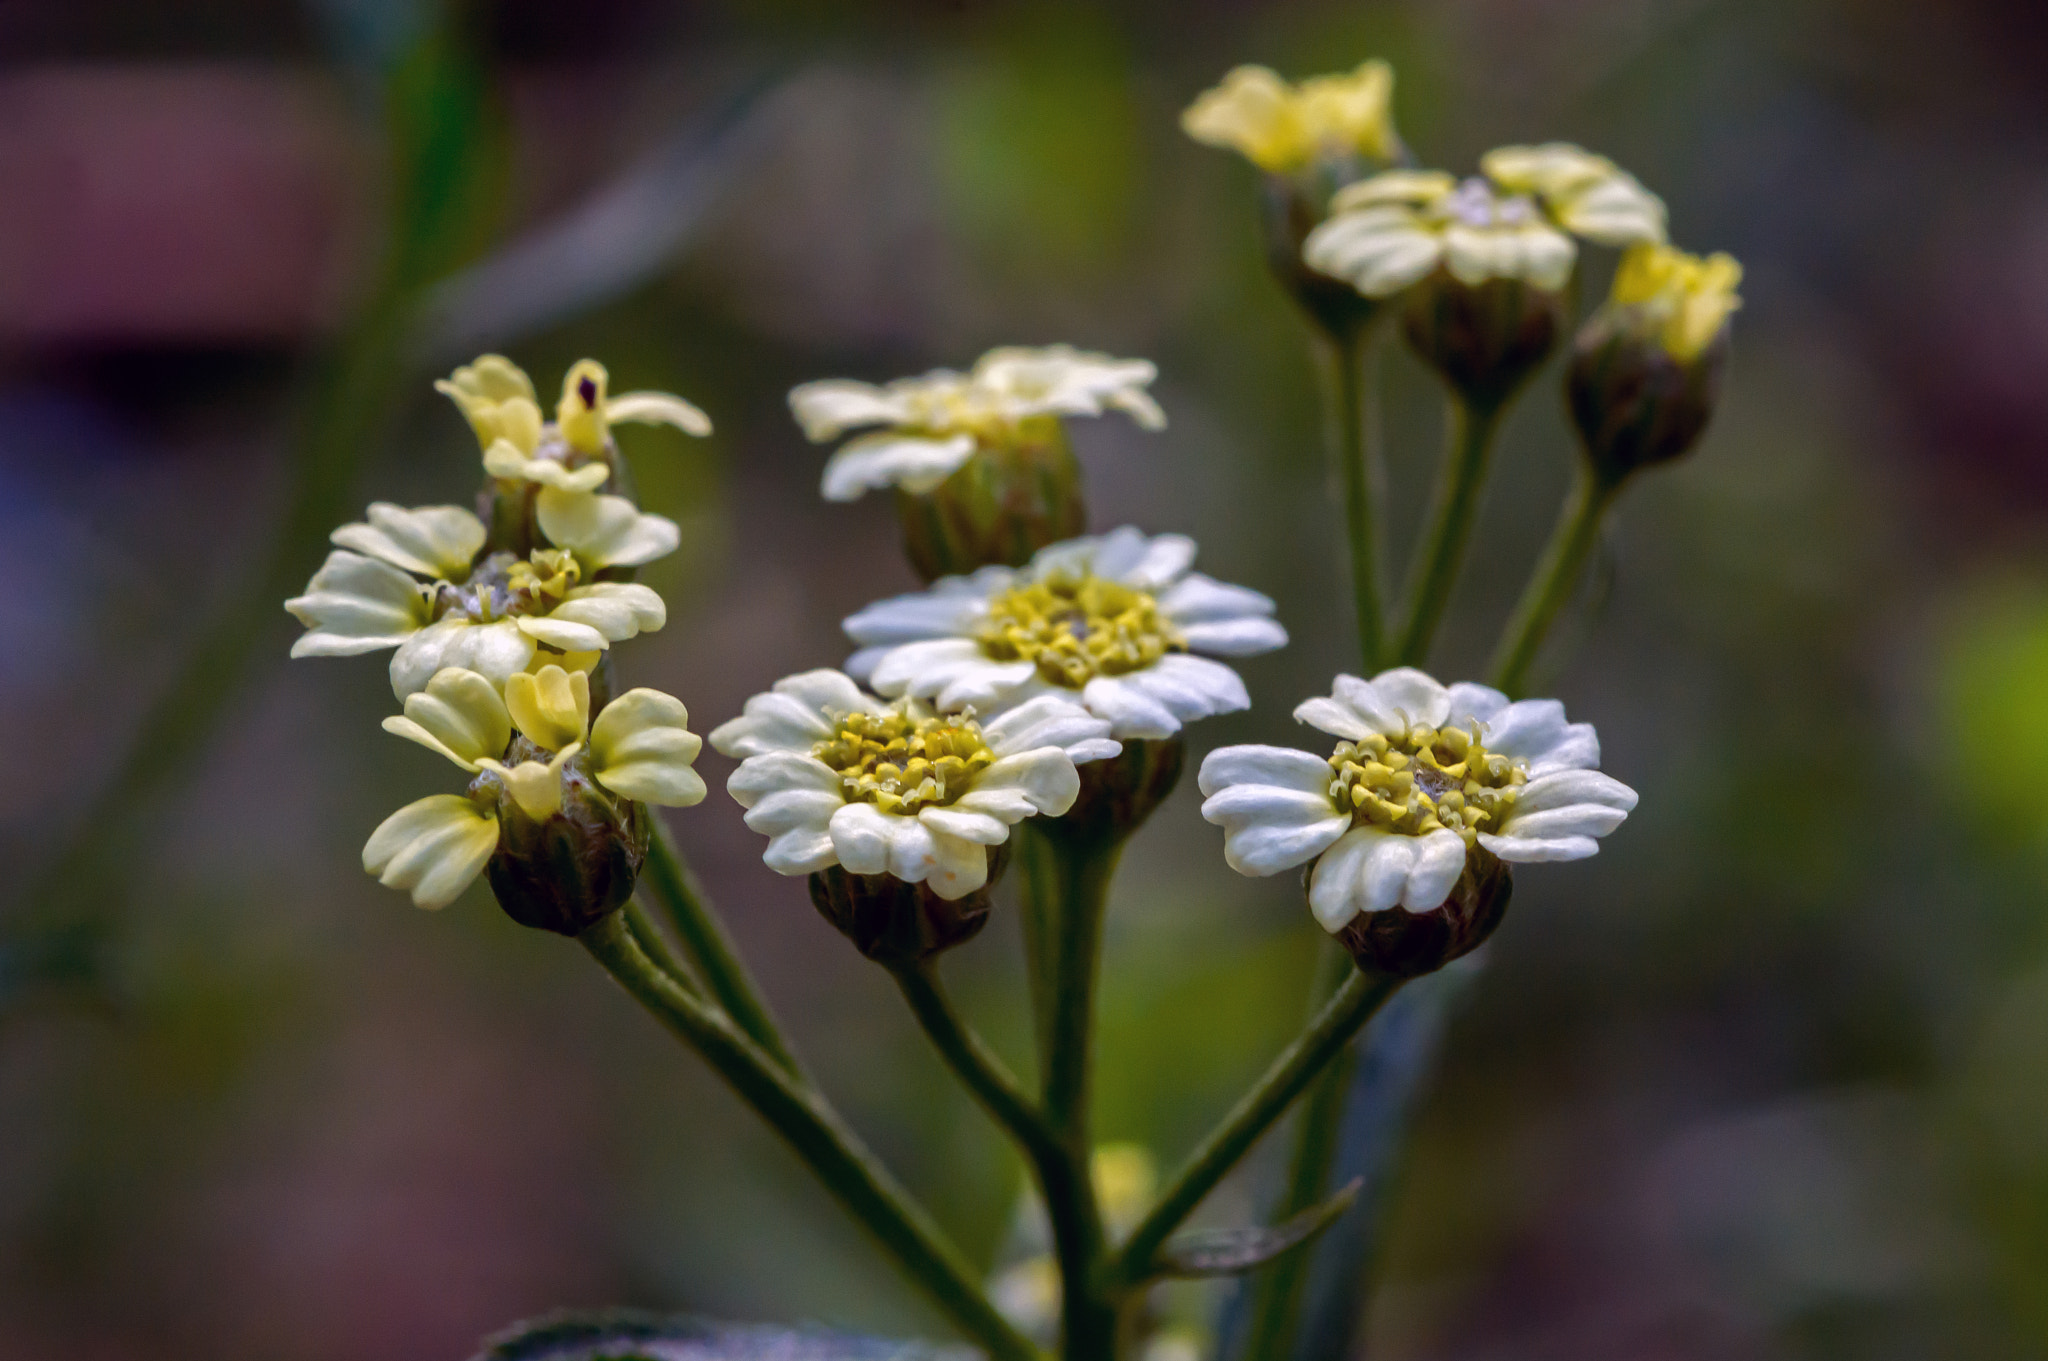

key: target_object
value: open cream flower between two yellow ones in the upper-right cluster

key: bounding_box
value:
[1303,143,1665,297]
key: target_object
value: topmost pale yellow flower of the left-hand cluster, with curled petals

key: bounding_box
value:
[434,354,711,491]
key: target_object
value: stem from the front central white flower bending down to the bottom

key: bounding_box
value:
[895,962,1116,1357]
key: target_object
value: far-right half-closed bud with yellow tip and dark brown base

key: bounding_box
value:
[1565,246,1743,487]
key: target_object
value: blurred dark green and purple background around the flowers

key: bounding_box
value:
[0,0,2048,1361]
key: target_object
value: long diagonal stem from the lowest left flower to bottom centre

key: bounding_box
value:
[578,913,1042,1361]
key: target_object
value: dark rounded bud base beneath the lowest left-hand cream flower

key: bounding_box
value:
[483,737,649,935]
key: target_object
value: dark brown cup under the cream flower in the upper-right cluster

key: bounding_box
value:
[1401,270,1565,411]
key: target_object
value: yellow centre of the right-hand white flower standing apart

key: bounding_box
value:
[1329,725,1530,845]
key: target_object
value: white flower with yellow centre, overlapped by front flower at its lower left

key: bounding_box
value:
[846,526,1286,741]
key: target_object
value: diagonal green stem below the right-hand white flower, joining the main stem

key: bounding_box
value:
[1112,970,1401,1283]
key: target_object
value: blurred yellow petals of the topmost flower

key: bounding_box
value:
[1180,59,1401,174]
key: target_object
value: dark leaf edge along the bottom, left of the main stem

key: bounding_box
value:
[471,1310,963,1361]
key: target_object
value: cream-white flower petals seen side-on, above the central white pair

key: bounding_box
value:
[788,346,1165,501]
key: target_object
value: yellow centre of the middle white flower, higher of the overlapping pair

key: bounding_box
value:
[975,575,1188,690]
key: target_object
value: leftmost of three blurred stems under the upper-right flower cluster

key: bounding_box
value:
[1315,323,1386,675]
